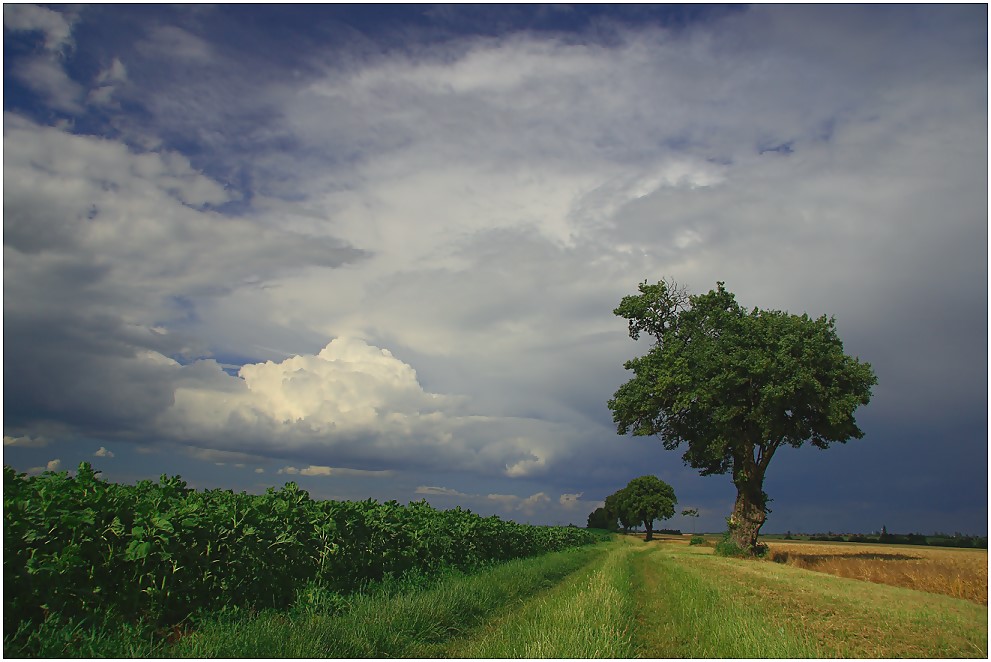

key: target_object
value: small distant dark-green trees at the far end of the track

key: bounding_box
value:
[588,476,678,540]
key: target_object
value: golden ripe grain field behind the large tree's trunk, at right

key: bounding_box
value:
[767,540,988,605]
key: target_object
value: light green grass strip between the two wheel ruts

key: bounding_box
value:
[443,543,637,658]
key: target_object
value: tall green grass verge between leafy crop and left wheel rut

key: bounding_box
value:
[168,546,606,658]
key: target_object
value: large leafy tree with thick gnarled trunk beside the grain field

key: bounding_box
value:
[609,281,877,553]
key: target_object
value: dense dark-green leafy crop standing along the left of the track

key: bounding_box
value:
[3,462,597,656]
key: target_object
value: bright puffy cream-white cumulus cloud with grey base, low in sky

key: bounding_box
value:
[157,337,560,476]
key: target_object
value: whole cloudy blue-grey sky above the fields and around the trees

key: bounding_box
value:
[3,4,988,535]
